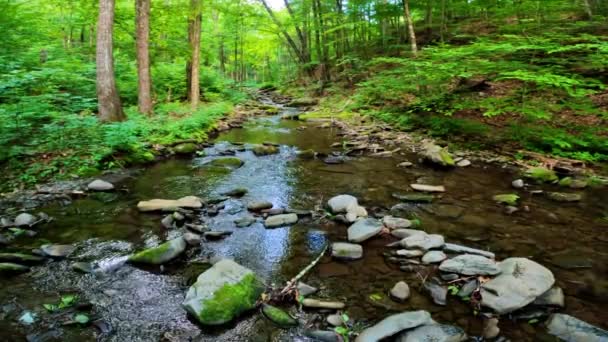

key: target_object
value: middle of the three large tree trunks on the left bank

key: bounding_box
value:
[135,0,152,115]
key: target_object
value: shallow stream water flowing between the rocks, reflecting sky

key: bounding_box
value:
[0,100,608,341]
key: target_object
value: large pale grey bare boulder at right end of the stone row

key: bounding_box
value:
[481,258,555,315]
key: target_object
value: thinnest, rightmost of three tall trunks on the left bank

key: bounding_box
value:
[188,0,202,108]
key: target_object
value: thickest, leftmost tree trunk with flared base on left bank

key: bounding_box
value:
[96,0,125,122]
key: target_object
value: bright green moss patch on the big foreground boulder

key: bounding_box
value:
[197,273,264,325]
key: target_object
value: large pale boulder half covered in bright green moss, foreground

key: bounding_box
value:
[182,259,264,325]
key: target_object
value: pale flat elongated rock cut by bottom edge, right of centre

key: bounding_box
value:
[355,310,433,342]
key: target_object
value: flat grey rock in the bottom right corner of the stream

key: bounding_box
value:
[547,314,608,342]
